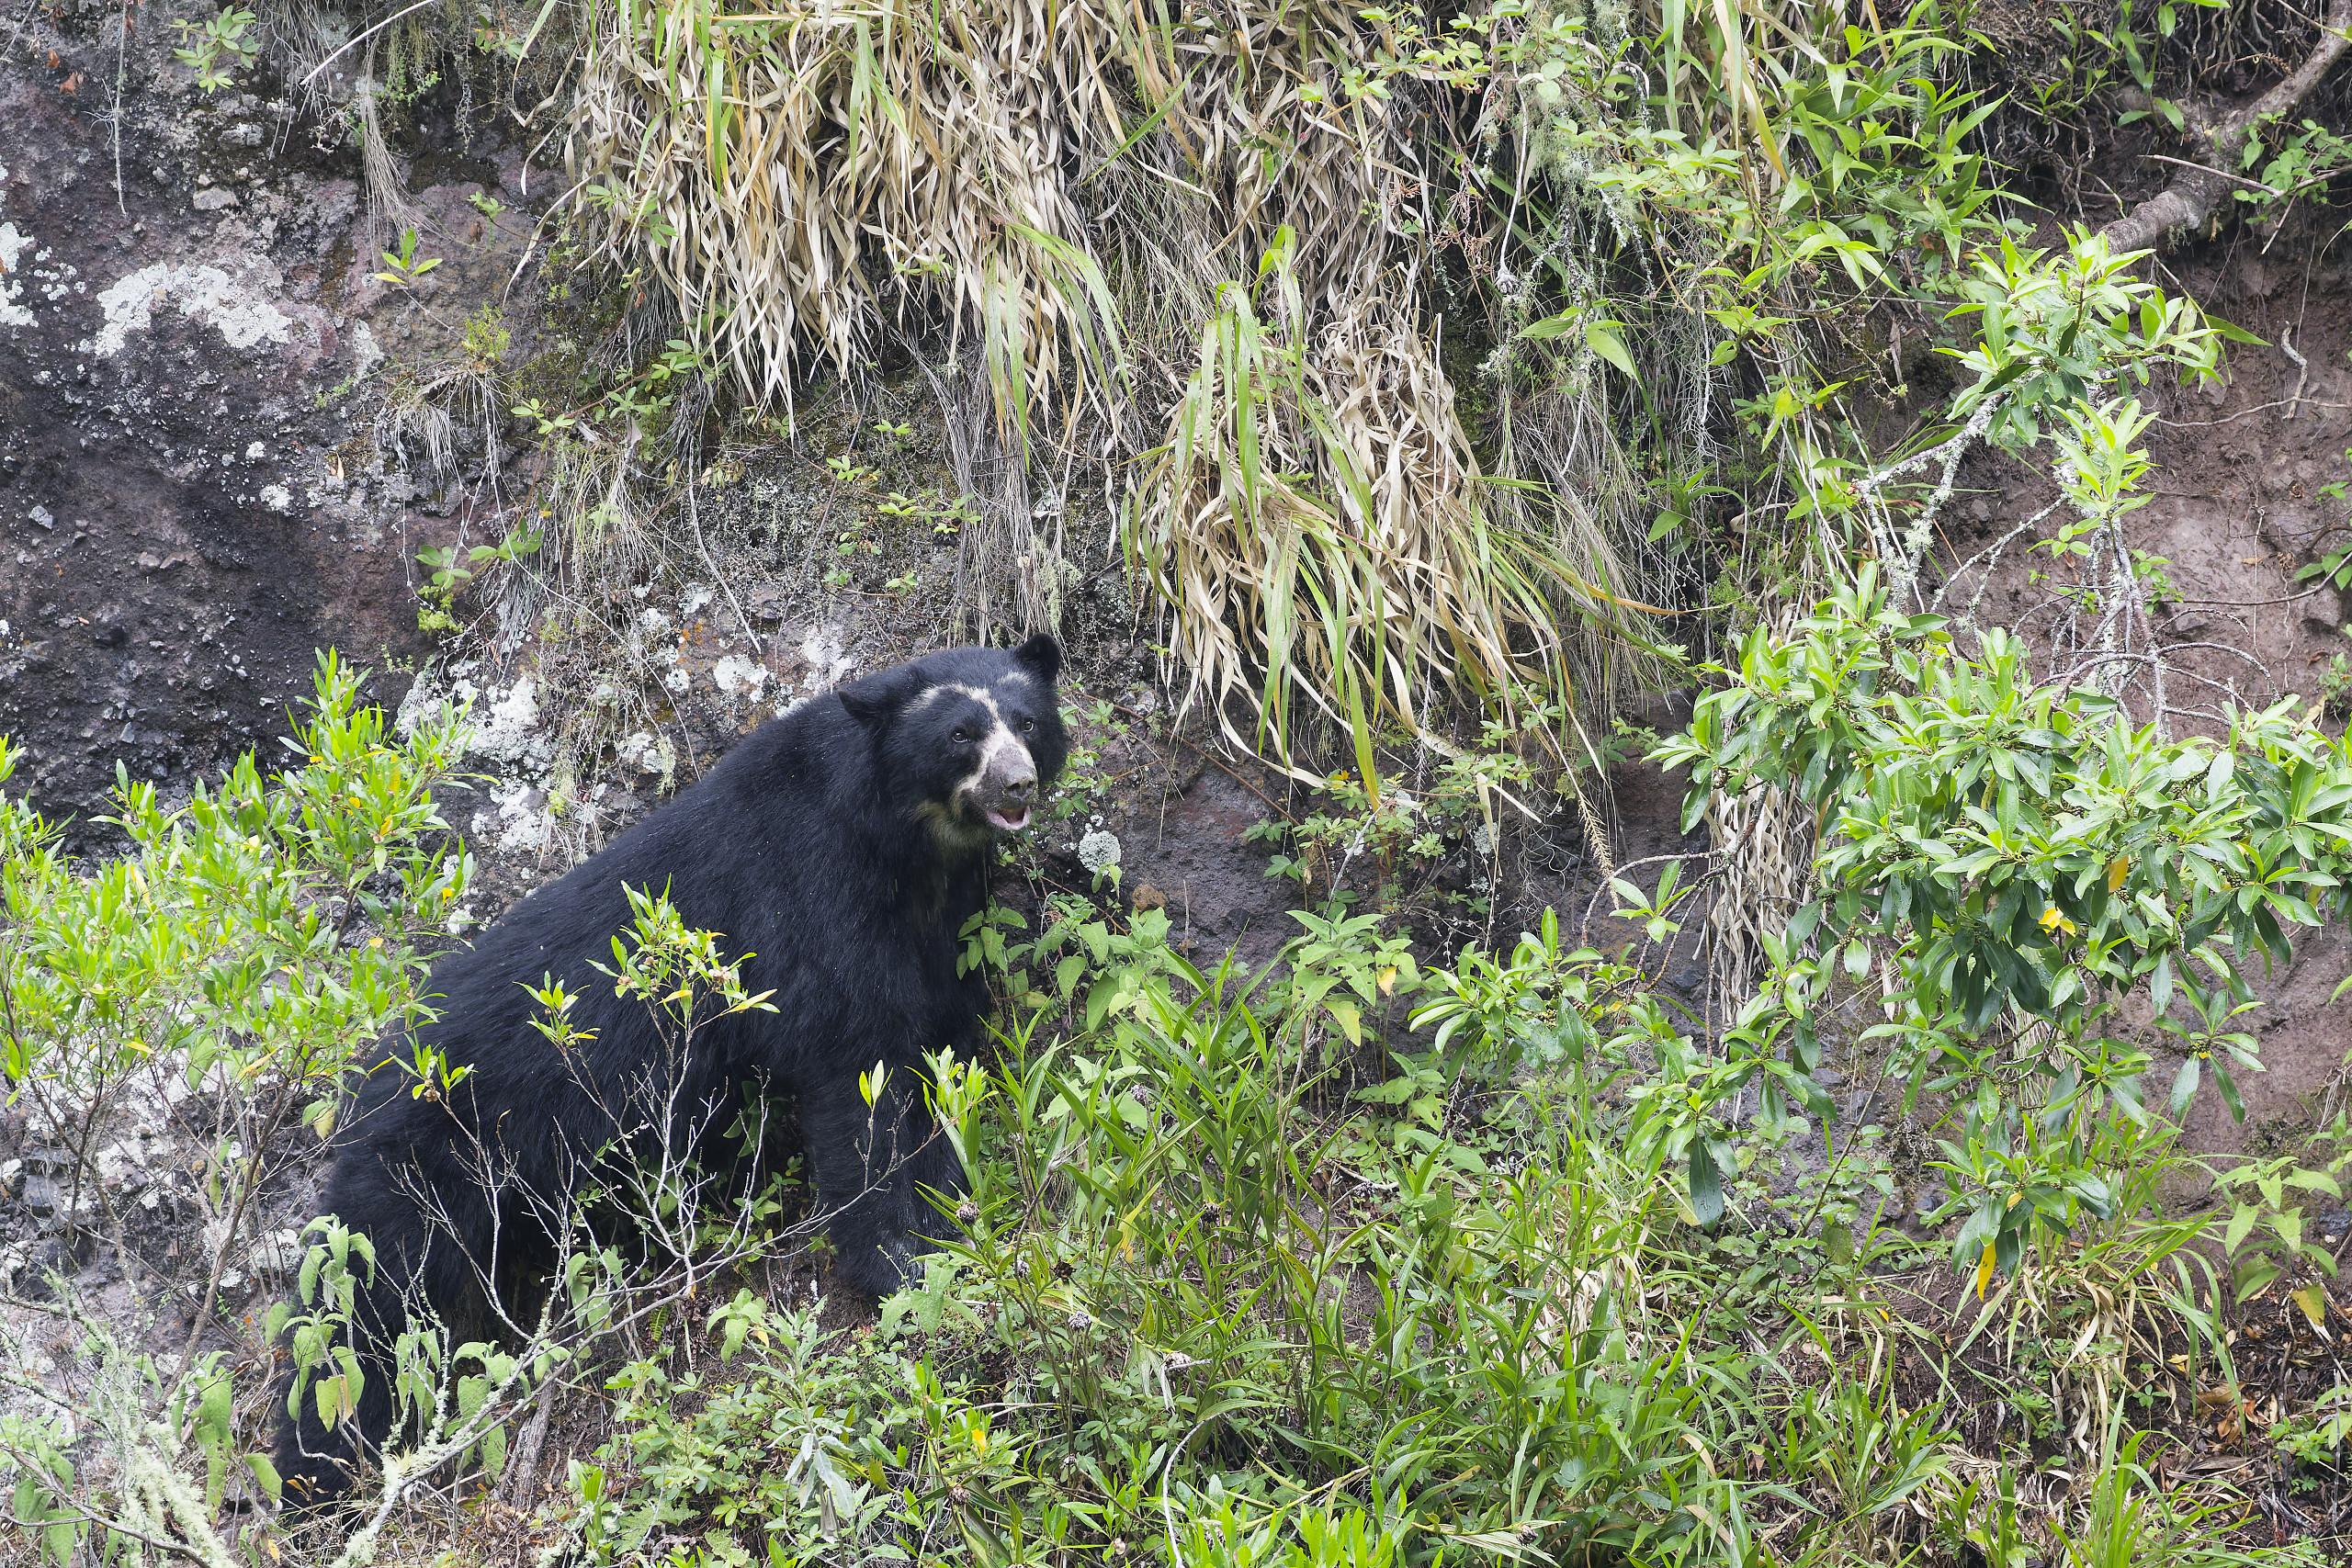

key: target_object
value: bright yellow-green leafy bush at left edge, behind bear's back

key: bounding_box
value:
[0,653,473,1142]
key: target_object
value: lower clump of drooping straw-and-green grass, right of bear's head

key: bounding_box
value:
[1129,264,1589,776]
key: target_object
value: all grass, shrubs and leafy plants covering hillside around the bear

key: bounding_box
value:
[14,0,2352,1568]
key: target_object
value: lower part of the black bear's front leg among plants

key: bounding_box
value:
[799,1067,965,1295]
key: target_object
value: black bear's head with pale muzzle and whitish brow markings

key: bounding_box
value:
[840,632,1070,851]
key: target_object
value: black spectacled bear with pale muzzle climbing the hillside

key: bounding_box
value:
[277,635,1068,1500]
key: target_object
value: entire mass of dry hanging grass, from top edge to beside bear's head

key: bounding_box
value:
[570,0,1747,773]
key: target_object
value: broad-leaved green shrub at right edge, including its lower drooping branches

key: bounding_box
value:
[1658,567,2352,1279]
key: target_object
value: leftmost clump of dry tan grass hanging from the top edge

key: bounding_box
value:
[571,0,1129,425]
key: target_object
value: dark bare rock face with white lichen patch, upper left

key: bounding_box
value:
[0,17,529,820]
